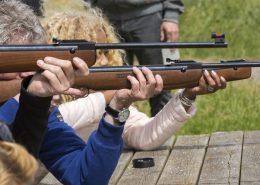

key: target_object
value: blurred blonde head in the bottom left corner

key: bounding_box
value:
[0,122,38,185]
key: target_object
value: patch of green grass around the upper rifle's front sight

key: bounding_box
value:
[180,0,260,60]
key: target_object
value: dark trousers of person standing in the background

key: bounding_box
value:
[112,12,172,116]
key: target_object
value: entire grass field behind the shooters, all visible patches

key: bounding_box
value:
[45,0,260,134]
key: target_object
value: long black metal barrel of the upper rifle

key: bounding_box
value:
[0,40,228,52]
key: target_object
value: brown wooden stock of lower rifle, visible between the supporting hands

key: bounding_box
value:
[75,69,202,91]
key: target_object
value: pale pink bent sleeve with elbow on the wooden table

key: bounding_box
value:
[123,92,196,150]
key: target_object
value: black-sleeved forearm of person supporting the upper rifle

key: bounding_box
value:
[11,78,51,157]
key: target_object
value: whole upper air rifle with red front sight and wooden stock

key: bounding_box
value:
[0,33,225,73]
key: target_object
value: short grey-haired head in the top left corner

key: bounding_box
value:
[0,0,45,44]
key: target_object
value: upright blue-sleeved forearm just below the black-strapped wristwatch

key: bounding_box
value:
[84,116,123,185]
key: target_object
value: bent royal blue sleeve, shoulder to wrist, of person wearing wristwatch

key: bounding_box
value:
[40,108,123,185]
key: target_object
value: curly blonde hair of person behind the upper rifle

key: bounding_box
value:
[44,4,123,66]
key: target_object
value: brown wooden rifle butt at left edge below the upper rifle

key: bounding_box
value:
[0,80,21,103]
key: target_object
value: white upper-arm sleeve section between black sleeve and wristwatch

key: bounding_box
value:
[59,92,106,132]
